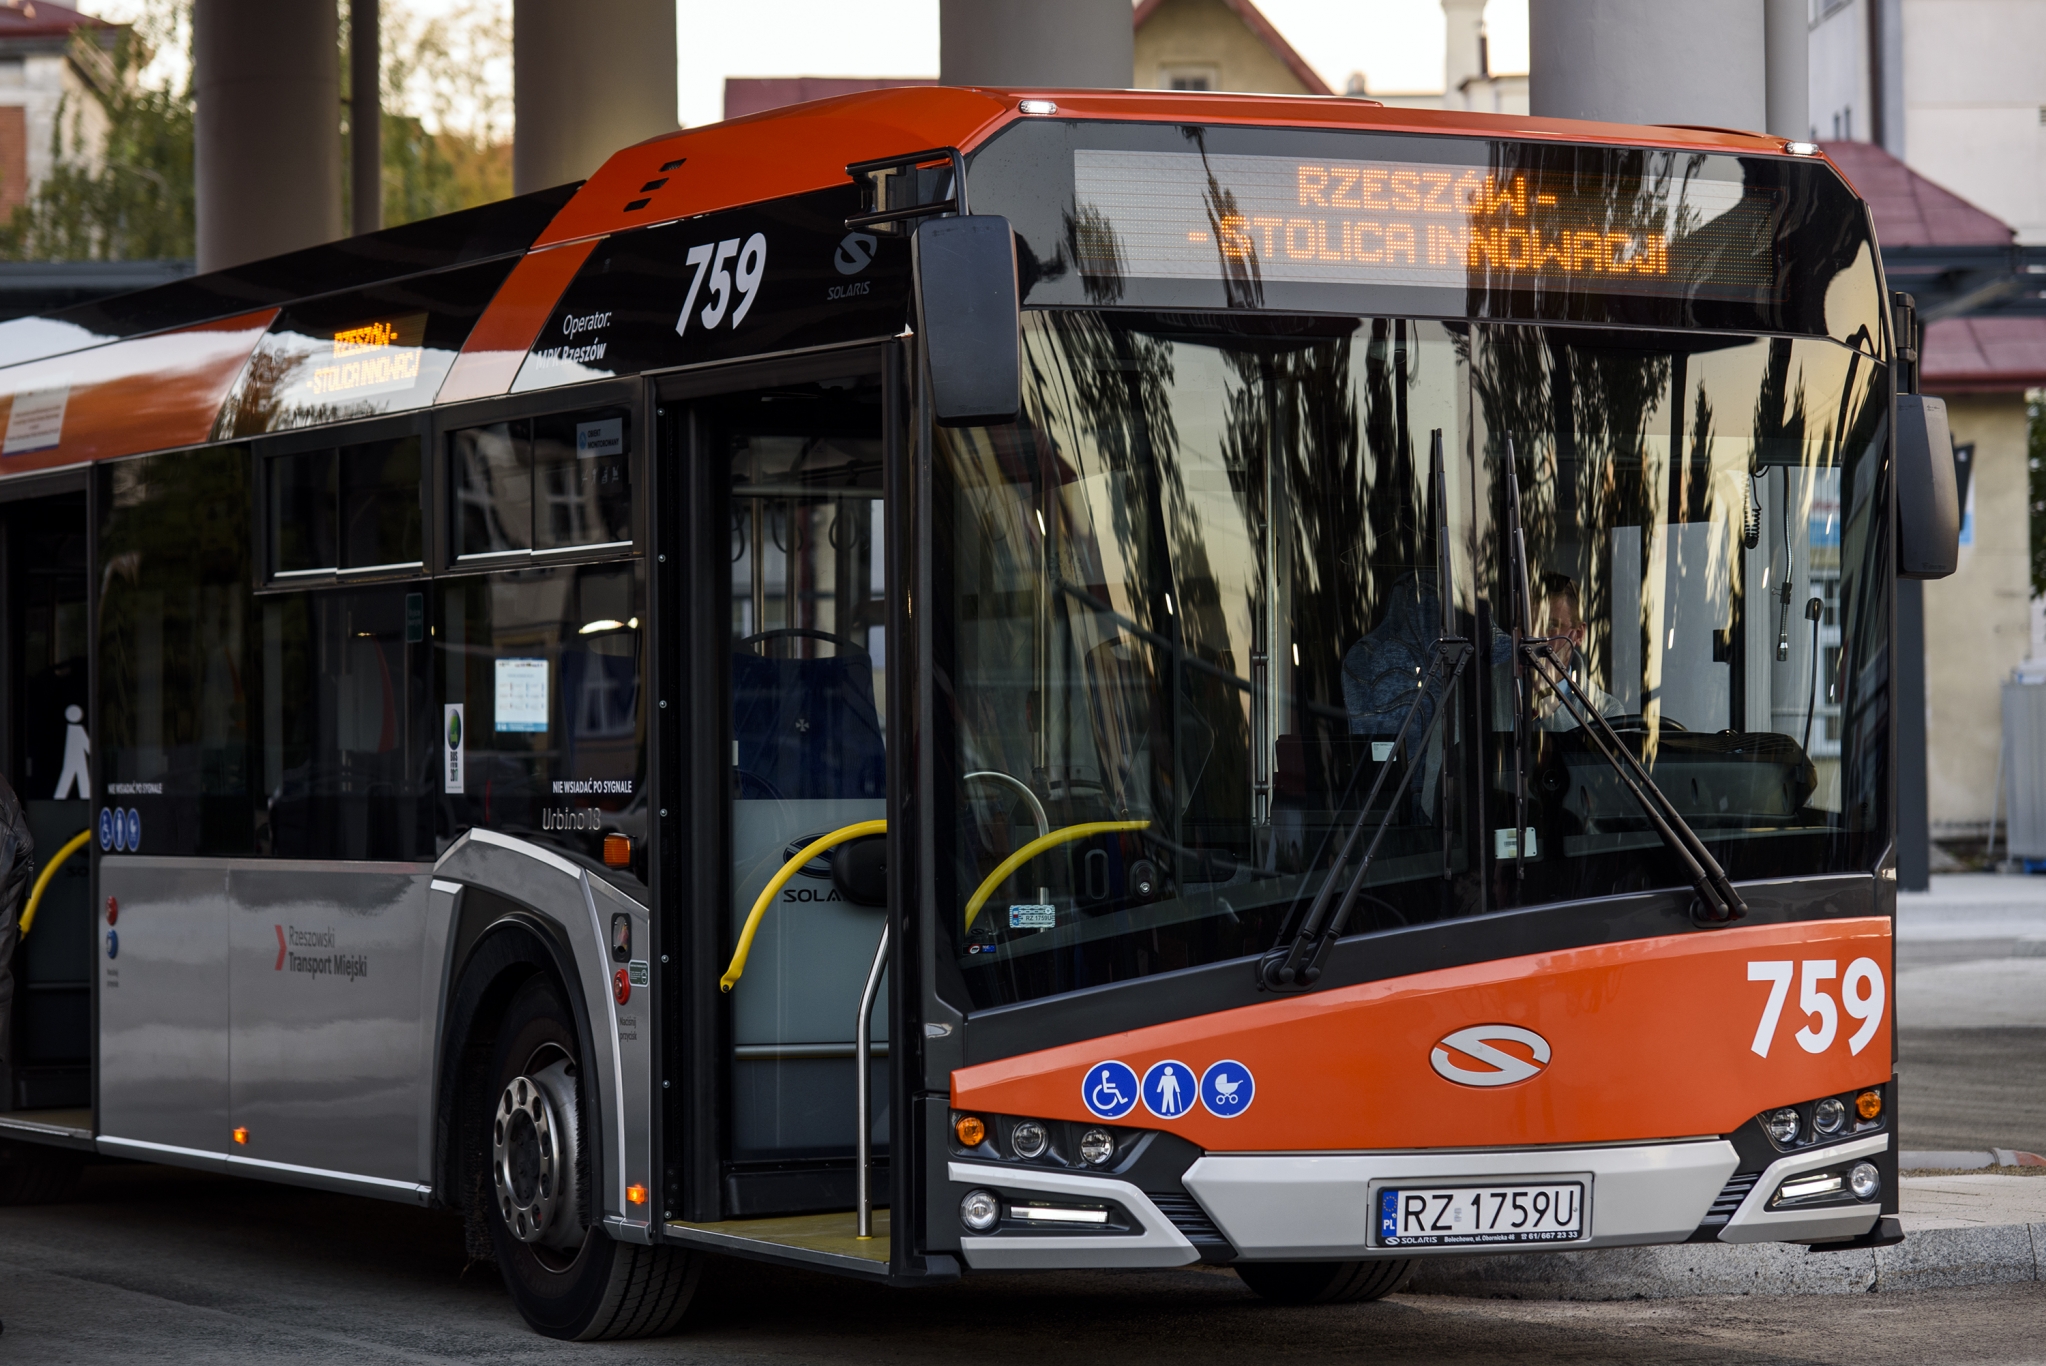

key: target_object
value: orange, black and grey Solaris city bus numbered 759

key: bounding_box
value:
[0,88,1954,1337]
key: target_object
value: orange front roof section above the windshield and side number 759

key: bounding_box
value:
[534,86,1816,247]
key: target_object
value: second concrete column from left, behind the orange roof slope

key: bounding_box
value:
[512,0,677,194]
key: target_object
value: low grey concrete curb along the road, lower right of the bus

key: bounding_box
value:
[1408,1223,2046,1301]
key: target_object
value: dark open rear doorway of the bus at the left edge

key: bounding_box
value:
[0,493,92,1127]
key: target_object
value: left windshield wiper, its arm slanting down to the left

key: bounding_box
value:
[1258,427,1471,992]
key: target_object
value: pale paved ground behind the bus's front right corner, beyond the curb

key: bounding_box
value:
[1897,873,2046,1153]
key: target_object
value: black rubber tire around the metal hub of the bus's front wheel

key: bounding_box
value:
[481,975,702,1341]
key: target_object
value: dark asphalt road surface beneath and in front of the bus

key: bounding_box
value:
[0,1168,2046,1366]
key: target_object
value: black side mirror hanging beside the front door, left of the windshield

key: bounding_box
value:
[910,215,1023,427]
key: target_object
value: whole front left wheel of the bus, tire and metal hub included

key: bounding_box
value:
[481,975,700,1341]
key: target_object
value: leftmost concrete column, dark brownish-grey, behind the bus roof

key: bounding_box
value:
[192,0,342,270]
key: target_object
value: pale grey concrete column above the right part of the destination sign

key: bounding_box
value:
[1528,0,1768,129]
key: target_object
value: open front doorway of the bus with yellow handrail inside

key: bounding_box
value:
[657,350,902,1274]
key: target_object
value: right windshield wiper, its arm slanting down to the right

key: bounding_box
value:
[1506,438,1747,924]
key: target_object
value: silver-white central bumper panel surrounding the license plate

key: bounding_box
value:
[1185,1139,1739,1262]
